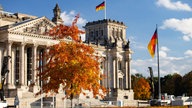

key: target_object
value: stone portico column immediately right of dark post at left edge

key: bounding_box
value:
[6,41,13,85]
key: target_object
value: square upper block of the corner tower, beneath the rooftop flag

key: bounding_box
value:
[85,19,127,45]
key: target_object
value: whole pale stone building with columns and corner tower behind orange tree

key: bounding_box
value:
[0,5,133,108]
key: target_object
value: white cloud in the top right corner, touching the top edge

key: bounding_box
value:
[157,0,192,11]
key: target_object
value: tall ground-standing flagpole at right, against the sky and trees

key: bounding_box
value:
[156,24,161,100]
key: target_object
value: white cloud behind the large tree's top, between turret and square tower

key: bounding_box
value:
[61,10,87,41]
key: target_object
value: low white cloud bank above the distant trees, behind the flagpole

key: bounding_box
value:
[131,46,192,77]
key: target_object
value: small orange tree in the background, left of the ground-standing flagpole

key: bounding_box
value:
[133,78,151,100]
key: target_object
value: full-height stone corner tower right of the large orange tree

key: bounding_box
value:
[85,19,134,103]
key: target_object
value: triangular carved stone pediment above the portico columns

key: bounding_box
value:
[8,17,56,35]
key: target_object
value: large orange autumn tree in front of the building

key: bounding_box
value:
[36,16,105,98]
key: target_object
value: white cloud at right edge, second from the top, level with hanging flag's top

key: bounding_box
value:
[160,18,192,41]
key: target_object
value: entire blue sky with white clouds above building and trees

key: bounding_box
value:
[0,0,192,76]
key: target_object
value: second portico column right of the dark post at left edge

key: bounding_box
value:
[19,43,25,86]
